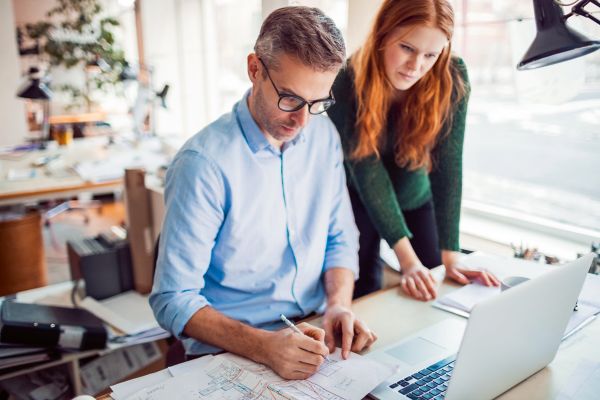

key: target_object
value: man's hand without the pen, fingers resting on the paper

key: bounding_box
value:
[323,306,377,360]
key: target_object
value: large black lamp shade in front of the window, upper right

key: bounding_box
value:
[517,0,600,70]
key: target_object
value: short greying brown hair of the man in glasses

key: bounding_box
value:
[254,6,346,71]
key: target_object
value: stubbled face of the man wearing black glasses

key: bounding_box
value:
[248,54,338,147]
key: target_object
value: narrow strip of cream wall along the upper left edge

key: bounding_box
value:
[0,0,27,146]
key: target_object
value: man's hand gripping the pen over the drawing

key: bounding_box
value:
[263,322,329,379]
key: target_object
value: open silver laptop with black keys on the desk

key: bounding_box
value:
[367,254,594,400]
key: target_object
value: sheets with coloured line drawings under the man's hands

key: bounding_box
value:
[122,349,395,400]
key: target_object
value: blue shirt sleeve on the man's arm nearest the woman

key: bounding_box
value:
[324,124,358,279]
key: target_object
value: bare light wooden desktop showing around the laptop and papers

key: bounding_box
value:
[99,272,600,400]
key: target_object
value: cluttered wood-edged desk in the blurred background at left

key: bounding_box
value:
[0,137,167,206]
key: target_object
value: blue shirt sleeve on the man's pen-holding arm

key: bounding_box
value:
[150,150,225,338]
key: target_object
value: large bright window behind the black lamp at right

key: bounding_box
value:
[453,0,600,233]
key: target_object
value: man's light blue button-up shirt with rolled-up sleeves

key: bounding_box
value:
[150,92,358,354]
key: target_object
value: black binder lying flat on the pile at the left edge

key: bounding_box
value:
[0,301,108,350]
